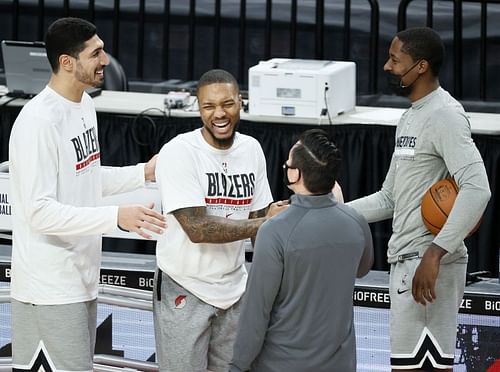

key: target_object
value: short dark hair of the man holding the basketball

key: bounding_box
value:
[396,27,444,77]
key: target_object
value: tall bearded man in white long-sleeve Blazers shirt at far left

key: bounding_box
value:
[9,18,166,371]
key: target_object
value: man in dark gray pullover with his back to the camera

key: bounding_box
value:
[230,130,373,372]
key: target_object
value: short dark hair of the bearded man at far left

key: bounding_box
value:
[45,17,97,73]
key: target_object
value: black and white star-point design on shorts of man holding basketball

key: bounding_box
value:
[391,327,454,369]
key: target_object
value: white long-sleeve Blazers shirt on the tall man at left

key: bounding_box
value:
[9,87,144,305]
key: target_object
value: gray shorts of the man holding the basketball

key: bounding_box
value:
[389,259,467,369]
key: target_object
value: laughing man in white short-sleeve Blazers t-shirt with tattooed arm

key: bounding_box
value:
[154,70,284,372]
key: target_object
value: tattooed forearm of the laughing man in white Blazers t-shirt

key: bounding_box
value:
[173,207,265,243]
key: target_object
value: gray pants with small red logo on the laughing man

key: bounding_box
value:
[153,270,241,372]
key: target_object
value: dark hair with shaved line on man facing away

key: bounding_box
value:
[292,129,340,194]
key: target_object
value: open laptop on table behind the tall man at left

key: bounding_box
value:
[2,40,52,98]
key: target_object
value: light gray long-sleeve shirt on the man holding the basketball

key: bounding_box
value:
[348,88,490,263]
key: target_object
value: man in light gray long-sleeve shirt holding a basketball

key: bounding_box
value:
[348,27,490,371]
